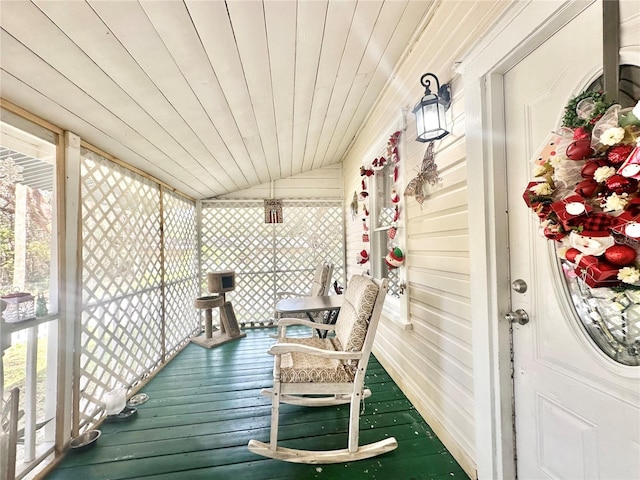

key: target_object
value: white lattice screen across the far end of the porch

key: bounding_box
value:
[201,200,344,325]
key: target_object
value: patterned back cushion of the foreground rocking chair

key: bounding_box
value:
[336,275,378,352]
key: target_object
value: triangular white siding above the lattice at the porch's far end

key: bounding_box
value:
[217,164,342,200]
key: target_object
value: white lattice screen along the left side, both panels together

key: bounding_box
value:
[77,149,199,428]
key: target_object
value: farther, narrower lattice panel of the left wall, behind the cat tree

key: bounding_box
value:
[162,190,200,354]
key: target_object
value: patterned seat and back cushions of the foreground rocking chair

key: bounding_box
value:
[280,275,378,383]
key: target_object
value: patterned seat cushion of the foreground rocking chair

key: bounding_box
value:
[280,337,355,383]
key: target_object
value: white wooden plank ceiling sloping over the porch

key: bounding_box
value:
[0,0,436,198]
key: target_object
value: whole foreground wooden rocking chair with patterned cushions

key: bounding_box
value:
[248,275,398,464]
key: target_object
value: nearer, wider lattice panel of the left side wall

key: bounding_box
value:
[79,149,162,424]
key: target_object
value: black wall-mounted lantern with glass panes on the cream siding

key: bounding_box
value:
[413,73,451,142]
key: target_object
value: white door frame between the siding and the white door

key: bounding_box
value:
[456,0,598,479]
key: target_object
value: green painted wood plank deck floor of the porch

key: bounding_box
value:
[46,329,468,480]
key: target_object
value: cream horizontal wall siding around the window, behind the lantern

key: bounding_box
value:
[343,2,509,478]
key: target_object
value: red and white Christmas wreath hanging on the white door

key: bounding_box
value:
[523,92,640,288]
